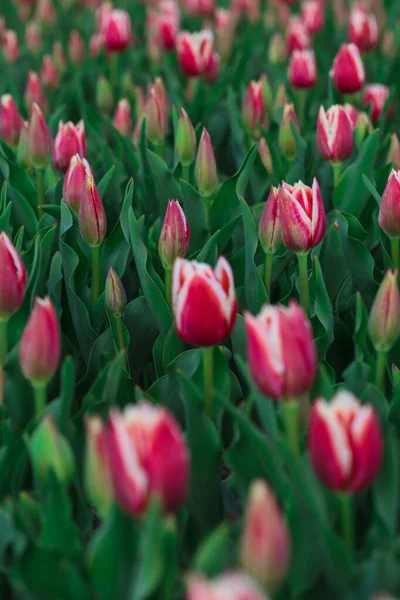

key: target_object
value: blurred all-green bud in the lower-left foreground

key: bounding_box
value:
[29,415,75,483]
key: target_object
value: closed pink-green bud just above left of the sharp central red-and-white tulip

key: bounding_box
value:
[158,200,190,269]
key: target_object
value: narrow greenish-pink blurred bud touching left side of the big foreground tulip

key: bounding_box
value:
[85,417,113,518]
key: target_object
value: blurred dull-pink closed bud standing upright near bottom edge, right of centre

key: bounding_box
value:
[240,479,291,593]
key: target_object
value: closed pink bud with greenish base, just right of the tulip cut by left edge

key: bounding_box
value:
[19,297,61,386]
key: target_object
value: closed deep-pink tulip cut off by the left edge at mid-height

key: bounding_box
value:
[0,231,26,321]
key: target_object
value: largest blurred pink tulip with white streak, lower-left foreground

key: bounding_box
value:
[98,402,189,516]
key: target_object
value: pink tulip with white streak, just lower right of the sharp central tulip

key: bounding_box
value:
[245,300,317,400]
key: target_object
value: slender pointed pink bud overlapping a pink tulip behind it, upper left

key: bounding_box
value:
[78,160,107,248]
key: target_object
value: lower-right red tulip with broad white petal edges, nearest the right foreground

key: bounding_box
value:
[308,390,383,493]
